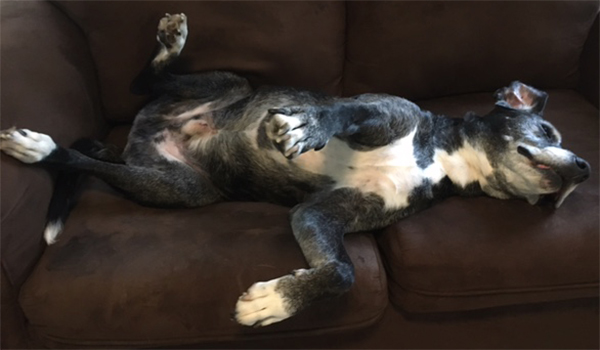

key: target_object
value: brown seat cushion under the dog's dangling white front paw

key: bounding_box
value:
[20,180,388,347]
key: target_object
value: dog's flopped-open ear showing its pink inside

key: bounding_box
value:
[494,81,548,115]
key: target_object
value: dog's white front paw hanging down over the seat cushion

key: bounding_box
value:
[234,277,292,327]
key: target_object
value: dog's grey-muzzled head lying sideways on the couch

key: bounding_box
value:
[474,82,590,208]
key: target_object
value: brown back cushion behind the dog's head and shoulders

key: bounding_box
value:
[344,1,598,99]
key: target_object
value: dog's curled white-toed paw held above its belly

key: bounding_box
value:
[267,106,331,159]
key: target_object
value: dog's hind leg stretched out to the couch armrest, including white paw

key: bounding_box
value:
[0,128,221,207]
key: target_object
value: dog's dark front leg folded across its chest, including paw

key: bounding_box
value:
[266,94,423,159]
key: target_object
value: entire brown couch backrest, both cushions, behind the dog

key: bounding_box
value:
[57,0,598,121]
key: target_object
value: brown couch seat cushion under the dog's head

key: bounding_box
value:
[378,91,599,312]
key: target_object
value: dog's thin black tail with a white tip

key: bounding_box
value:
[44,138,122,245]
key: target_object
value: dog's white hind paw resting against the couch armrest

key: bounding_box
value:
[0,128,56,163]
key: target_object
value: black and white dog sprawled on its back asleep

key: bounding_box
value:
[0,14,590,326]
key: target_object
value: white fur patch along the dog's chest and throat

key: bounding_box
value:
[294,130,493,209]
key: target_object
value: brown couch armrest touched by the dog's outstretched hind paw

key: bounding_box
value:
[0,1,104,292]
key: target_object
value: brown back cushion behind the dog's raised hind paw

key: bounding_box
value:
[57,1,345,121]
